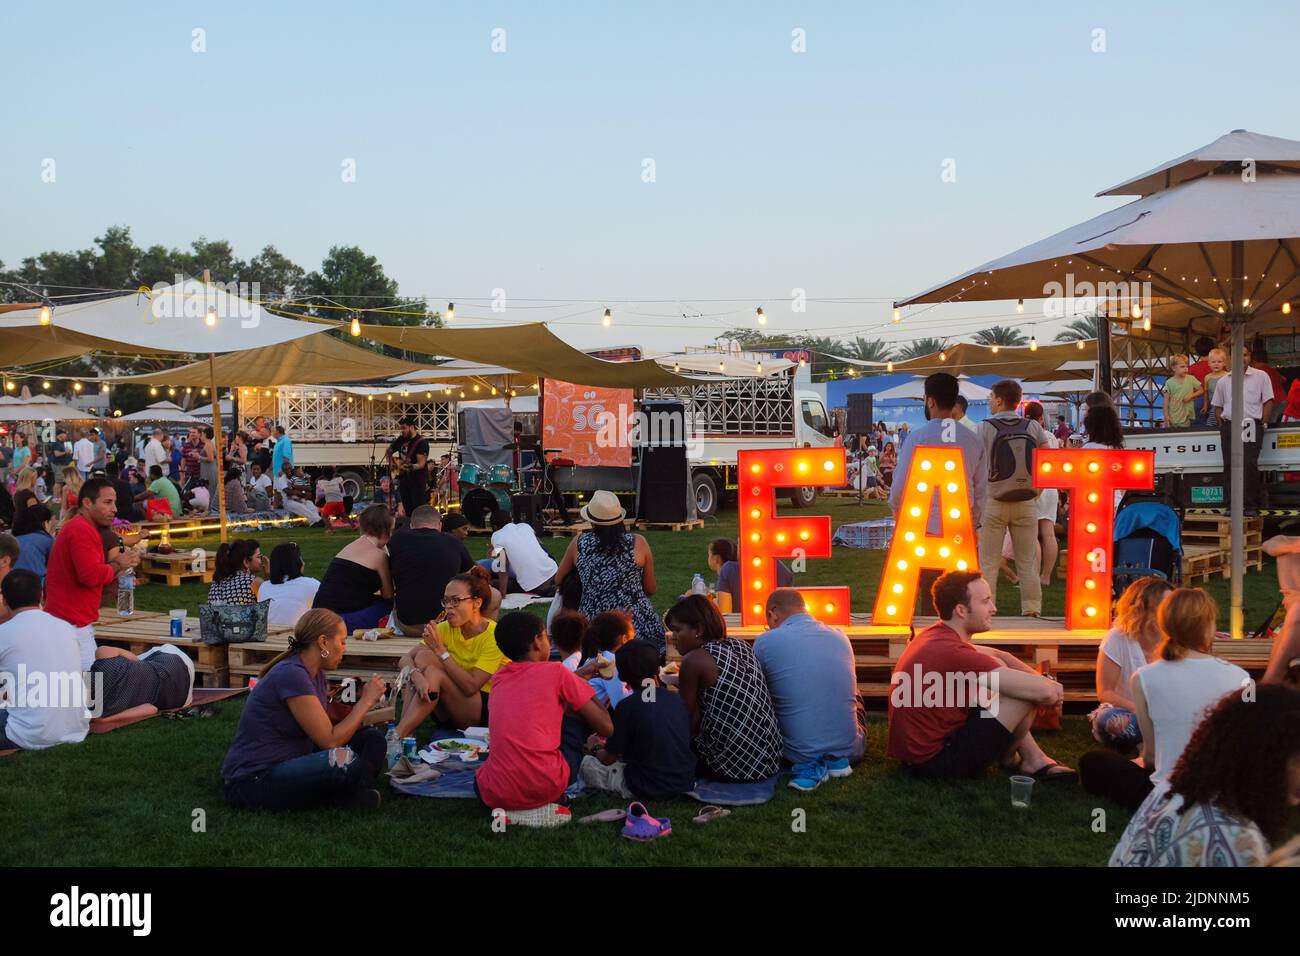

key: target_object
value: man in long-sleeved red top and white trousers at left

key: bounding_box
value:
[46,479,140,670]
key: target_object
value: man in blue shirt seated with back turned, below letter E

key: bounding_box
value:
[754,588,866,791]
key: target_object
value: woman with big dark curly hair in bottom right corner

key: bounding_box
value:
[1110,684,1300,866]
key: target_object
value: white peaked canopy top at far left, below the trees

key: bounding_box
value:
[0,280,329,354]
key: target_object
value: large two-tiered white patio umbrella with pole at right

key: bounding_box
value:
[894,130,1300,637]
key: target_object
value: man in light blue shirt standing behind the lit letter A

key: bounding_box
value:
[889,372,988,614]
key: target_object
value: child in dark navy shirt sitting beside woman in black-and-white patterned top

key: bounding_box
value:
[581,641,696,800]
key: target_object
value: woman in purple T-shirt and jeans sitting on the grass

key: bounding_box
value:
[221,607,385,810]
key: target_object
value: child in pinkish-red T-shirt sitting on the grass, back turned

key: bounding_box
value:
[475,611,614,826]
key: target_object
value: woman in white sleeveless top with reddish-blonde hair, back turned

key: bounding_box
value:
[1079,587,1251,810]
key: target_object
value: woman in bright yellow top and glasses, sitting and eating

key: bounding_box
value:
[398,566,506,737]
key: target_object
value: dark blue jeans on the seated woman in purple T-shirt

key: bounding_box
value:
[225,727,386,810]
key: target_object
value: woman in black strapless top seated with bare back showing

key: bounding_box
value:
[312,505,393,631]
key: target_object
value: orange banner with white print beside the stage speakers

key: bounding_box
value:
[542,378,636,468]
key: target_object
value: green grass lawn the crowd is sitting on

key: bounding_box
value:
[0,501,1277,866]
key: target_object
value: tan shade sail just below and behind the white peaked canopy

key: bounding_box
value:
[101,326,419,386]
